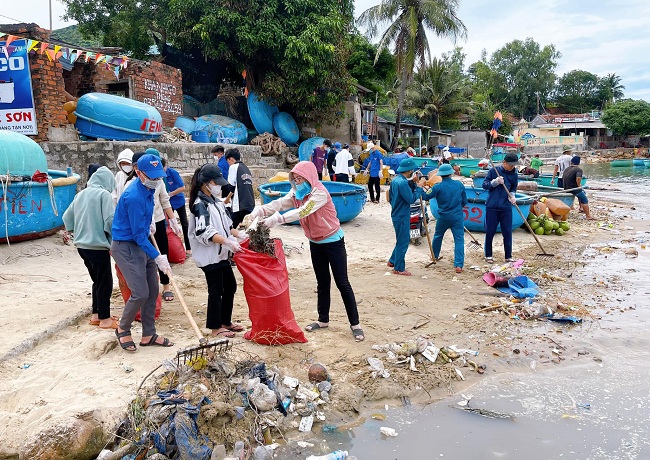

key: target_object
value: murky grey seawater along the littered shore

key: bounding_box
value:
[306,164,650,460]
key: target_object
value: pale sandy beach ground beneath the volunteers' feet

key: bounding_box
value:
[0,189,645,458]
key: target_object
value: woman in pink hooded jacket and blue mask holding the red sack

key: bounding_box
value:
[251,161,365,342]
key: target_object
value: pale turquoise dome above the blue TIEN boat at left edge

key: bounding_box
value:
[0,131,47,177]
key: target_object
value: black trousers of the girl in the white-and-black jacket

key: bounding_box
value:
[201,262,237,329]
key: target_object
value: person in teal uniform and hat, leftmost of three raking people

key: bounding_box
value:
[387,157,425,276]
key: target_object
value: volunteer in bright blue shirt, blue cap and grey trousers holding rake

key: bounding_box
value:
[111,154,174,352]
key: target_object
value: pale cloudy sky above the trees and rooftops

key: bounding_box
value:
[0,0,650,101]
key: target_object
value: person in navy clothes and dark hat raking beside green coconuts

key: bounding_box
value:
[483,153,520,264]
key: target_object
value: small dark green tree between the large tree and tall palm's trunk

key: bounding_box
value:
[347,33,395,102]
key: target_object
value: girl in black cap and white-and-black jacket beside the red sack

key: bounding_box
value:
[189,164,245,338]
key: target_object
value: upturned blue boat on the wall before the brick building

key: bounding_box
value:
[74,93,162,141]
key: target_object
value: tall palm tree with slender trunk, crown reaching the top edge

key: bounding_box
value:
[358,0,467,147]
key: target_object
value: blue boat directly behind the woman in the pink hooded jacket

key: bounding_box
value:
[258,181,366,224]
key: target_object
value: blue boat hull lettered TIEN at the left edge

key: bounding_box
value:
[0,170,80,243]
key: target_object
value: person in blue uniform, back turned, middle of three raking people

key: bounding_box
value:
[422,163,467,273]
